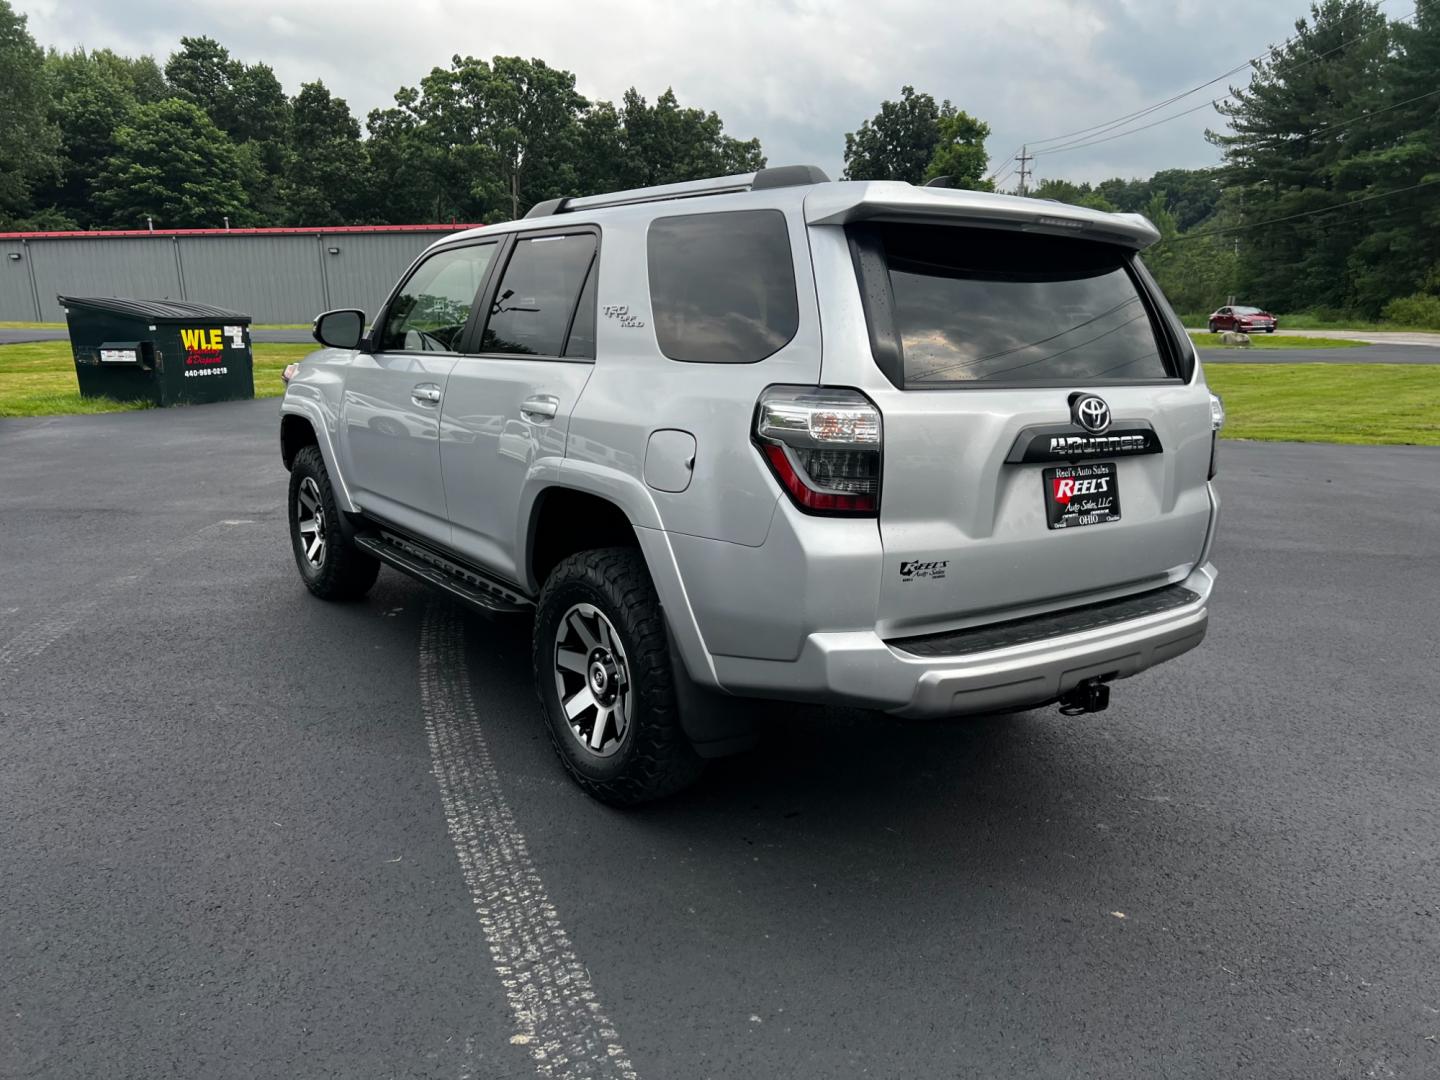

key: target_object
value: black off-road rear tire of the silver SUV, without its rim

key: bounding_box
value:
[531,547,704,806]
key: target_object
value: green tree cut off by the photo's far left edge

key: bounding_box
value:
[0,0,60,228]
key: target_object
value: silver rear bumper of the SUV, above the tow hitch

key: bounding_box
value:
[714,563,1215,717]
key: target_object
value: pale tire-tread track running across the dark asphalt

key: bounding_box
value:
[420,600,636,1080]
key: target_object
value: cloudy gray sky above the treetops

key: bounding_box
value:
[12,0,1313,187]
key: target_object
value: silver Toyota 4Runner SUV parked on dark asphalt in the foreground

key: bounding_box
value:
[281,166,1224,804]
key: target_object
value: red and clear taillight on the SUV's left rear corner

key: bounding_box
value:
[755,386,881,514]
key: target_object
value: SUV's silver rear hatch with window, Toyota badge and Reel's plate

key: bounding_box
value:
[824,204,1212,638]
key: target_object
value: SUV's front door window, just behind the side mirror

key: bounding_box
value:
[380,240,498,353]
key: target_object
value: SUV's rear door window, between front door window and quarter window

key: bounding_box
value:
[480,232,595,356]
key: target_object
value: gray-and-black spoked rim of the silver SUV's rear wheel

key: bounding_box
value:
[554,603,634,757]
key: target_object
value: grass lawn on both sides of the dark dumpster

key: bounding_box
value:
[0,341,315,416]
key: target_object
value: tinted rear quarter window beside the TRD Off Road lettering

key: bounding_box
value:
[649,210,801,364]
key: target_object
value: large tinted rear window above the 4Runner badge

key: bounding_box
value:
[851,225,1172,389]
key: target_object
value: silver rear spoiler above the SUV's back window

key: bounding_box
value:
[805,180,1161,251]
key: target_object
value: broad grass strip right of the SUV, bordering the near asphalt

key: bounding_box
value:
[1205,364,1440,446]
